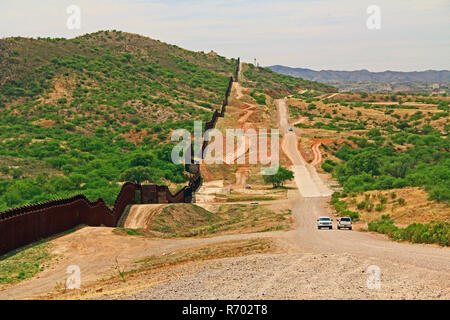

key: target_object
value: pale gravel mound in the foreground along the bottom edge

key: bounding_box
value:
[101,253,450,300]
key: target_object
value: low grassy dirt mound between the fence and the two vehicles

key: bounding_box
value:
[118,203,293,238]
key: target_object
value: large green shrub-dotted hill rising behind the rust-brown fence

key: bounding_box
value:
[0,31,330,210]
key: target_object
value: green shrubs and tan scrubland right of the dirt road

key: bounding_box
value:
[289,91,450,245]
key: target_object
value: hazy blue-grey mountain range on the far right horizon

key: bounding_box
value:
[269,65,450,92]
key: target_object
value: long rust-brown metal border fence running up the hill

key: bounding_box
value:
[0,58,240,255]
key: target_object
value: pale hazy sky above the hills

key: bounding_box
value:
[0,0,450,71]
